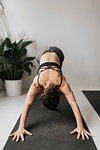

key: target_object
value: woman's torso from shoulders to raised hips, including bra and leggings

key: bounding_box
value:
[36,46,64,88]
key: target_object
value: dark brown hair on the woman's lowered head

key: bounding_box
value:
[40,86,60,111]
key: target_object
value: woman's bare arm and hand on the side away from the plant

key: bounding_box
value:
[60,76,92,140]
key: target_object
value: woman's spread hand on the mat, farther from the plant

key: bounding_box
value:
[70,126,93,140]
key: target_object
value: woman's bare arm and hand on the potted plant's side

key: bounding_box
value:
[9,76,41,142]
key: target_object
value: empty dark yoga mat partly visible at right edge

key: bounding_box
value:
[82,91,100,116]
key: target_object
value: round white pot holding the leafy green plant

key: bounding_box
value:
[5,79,22,96]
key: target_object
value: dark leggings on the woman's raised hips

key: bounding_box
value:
[36,46,64,66]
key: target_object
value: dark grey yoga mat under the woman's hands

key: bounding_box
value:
[4,95,97,150]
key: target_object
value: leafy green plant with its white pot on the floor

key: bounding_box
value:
[0,37,35,96]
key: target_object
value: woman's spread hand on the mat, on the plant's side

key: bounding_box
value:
[8,128,32,142]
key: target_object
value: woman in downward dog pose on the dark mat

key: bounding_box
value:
[9,47,92,142]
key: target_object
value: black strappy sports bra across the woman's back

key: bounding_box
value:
[37,62,63,90]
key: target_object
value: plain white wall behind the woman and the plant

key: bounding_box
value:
[2,0,100,88]
